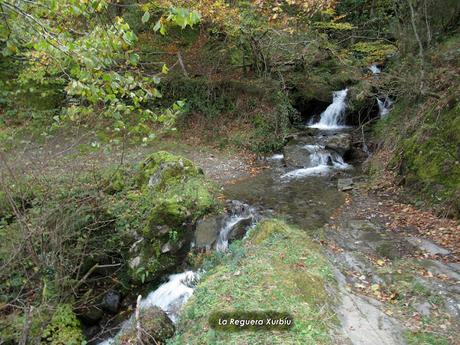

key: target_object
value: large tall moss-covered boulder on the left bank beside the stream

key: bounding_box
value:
[128,151,220,283]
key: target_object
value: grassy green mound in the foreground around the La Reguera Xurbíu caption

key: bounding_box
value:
[169,220,334,344]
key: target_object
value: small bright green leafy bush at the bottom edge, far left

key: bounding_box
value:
[42,304,86,345]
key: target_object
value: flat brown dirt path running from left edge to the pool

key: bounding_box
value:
[0,130,259,184]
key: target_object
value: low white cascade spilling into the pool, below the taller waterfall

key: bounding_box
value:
[281,145,351,179]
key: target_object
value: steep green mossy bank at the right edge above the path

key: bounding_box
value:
[372,97,460,216]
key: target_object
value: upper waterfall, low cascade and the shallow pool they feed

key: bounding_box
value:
[225,89,353,229]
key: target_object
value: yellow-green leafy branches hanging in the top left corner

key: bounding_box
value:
[0,0,200,141]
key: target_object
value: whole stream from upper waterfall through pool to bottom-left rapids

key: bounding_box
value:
[100,89,352,345]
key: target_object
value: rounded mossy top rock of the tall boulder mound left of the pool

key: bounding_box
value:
[137,151,203,191]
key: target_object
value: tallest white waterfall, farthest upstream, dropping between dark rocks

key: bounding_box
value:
[309,89,348,129]
